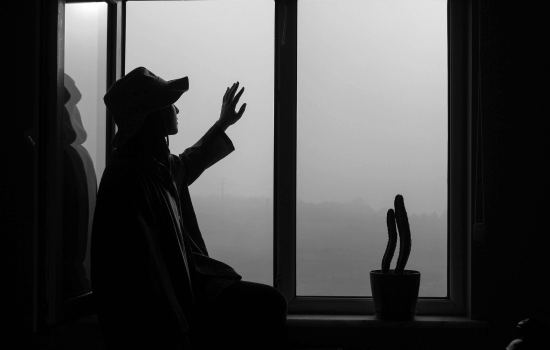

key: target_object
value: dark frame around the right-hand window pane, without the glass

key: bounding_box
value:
[273,0,473,316]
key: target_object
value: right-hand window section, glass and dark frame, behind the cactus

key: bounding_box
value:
[275,0,469,315]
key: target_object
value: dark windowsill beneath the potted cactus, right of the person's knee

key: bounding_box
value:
[286,314,487,349]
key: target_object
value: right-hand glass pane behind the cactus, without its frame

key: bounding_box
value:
[296,0,448,297]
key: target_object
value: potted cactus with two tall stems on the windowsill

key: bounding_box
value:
[370,194,420,321]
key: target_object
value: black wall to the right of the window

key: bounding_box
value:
[480,1,550,346]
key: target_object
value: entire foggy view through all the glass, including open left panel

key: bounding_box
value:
[65,0,447,296]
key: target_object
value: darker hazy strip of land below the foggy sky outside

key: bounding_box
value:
[193,195,447,297]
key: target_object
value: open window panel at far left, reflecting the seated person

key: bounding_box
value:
[33,1,120,330]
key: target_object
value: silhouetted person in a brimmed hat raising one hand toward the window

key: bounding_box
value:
[92,67,287,349]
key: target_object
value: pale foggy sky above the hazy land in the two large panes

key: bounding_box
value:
[126,0,447,214]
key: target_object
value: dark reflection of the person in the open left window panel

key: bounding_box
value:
[63,74,97,298]
